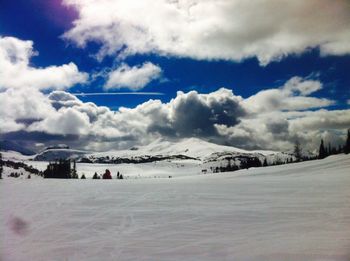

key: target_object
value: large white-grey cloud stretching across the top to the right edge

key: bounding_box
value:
[64,0,350,65]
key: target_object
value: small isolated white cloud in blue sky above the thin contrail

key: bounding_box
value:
[105,62,162,91]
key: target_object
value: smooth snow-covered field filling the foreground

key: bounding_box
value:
[0,155,350,261]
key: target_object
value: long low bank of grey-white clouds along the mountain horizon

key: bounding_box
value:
[0,74,350,150]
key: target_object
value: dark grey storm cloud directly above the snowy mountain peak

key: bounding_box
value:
[149,88,246,137]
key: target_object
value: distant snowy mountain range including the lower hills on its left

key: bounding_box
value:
[4,138,294,165]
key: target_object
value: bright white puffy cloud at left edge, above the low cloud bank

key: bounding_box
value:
[0,36,88,90]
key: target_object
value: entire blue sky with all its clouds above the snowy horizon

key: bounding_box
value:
[0,0,350,151]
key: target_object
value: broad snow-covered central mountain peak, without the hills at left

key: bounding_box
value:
[84,138,293,163]
